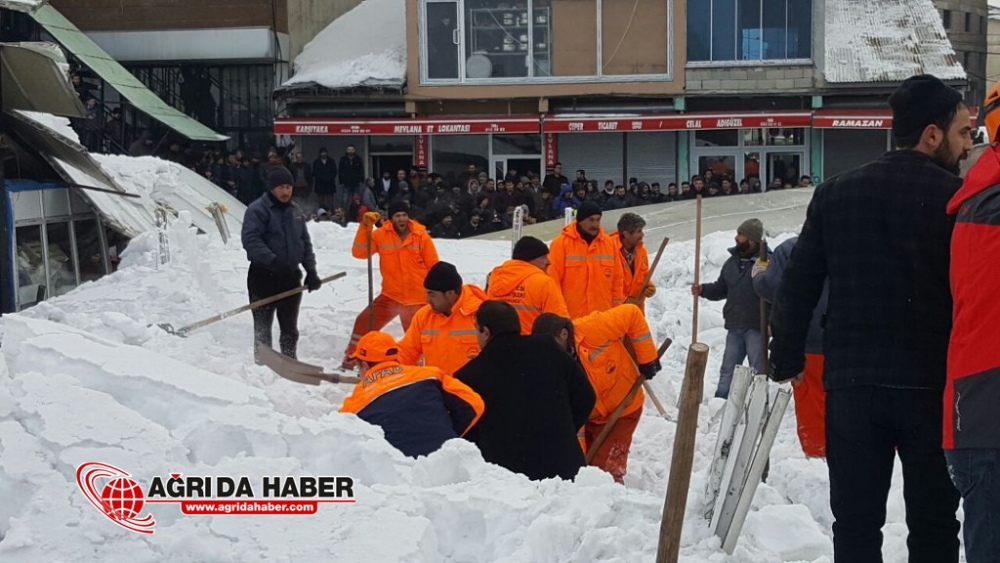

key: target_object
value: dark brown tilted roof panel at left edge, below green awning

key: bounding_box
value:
[0,43,87,117]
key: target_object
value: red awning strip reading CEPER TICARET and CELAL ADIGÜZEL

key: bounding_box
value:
[545,111,812,133]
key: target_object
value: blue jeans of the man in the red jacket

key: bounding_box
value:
[945,448,1000,563]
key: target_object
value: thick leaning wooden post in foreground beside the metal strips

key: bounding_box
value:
[656,342,708,563]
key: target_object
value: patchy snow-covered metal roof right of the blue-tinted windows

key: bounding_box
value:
[824,0,965,84]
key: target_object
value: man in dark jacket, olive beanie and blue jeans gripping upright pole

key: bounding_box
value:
[691,219,764,399]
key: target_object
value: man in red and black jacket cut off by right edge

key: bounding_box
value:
[944,81,1000,563]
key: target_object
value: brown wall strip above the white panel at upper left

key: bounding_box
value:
[51,0,288,32]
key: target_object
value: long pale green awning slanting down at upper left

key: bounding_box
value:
[32,6,229,141]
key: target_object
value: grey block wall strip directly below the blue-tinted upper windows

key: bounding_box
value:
[684,65,822,95]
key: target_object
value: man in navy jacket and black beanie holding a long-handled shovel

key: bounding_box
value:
[243,167,320,359]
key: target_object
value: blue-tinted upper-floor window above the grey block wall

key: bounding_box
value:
[687,0,812,62]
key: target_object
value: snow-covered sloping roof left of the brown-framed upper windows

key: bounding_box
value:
[282,0,406,89]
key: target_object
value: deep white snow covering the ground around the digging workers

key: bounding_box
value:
[0,214,952,563]
